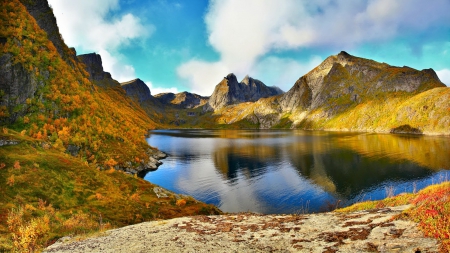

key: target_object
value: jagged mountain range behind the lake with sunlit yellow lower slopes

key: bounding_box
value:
[0,1,450,134]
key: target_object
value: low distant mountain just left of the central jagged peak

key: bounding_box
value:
[155,91,209,109]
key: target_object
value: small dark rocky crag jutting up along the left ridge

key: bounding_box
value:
[77,53,120,87]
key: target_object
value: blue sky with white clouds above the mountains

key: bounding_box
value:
[48,0,450,96]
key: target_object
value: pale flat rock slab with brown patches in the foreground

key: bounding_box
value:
[44,206,438,252]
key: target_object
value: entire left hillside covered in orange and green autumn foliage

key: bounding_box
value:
[0,0,220,252]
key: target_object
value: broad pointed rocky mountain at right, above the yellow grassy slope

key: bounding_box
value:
[280,51,445,111]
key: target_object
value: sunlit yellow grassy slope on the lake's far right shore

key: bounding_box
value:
[298,88,450,135]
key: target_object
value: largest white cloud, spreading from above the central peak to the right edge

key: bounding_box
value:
[178,0,450,94]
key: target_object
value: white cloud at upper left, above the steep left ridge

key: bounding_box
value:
[49,0,155,81]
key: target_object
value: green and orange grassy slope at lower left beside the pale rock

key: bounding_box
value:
[0,129,220,252]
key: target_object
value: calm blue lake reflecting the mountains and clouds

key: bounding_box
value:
[144,130,450,214]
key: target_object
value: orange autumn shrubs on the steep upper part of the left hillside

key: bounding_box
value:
[0,1,160,168]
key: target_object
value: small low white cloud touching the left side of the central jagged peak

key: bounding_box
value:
[177,60,230,96]
